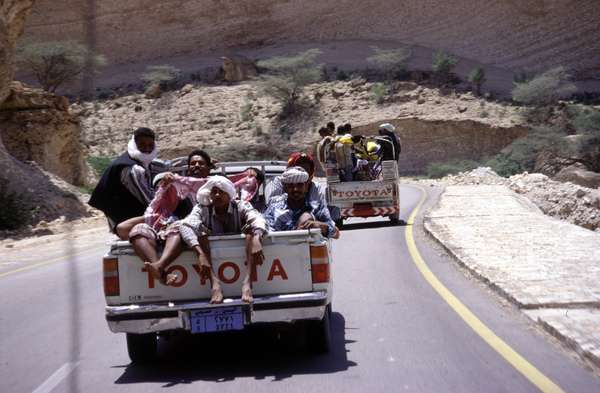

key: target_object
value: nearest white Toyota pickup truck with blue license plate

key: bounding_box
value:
[103,163,332,362]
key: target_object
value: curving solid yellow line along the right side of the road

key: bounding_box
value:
[405,186,563,393]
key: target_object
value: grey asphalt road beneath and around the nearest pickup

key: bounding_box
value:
[0,187,600,393]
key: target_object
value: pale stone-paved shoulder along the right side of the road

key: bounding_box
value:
[424,185,600,366]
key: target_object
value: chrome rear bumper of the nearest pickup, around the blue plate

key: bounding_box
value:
[106,291,329,333]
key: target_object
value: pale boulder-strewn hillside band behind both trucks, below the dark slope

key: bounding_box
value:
[71,79,526,173]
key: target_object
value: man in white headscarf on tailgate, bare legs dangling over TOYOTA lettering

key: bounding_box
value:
[147,176,267,303]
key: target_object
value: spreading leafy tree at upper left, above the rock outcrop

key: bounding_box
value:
[17,41,106,92]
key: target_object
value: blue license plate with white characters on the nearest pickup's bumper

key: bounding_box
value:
[190,307,244,333]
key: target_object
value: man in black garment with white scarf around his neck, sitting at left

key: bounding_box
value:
[88,127,157,234]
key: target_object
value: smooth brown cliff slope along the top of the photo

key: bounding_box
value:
[25,0,600,79]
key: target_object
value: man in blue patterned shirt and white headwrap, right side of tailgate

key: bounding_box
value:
[265,167,340,239]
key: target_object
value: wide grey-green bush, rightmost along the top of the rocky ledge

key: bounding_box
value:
[512,67,577,107]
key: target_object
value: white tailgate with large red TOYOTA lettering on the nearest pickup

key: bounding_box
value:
[115,231,313,305]
